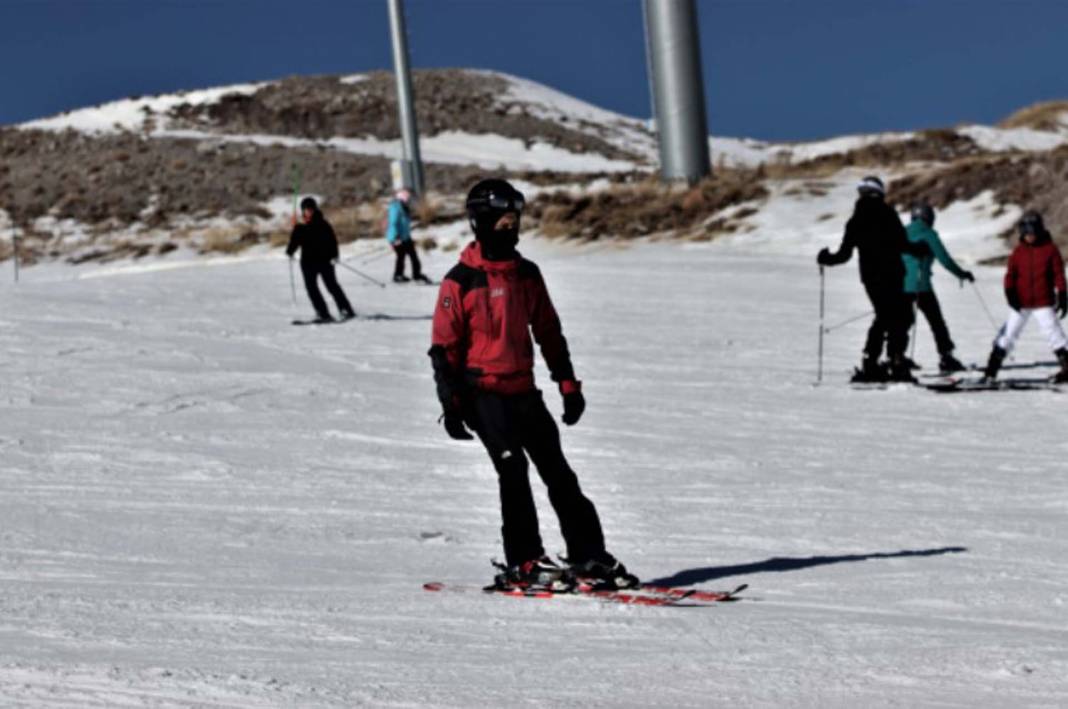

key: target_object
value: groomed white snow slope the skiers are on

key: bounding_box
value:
[0,239,1068,707]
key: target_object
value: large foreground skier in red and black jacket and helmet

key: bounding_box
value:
[428,179,638,590]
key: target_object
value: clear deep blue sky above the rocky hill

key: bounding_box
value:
[6,0,1068,140]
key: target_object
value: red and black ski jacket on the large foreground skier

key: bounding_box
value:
[431,241,577,394]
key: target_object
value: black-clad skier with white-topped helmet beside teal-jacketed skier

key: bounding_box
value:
[816,176,928,381]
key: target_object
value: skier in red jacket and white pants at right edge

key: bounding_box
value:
[984,211,1068,382]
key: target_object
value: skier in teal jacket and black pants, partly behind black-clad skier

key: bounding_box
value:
[901,204,975,372]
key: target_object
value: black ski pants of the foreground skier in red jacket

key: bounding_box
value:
[469,390,604,566]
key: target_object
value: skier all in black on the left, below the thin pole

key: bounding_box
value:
[285,196,356,322]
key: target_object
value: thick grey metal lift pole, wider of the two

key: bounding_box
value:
[643,0,711,184]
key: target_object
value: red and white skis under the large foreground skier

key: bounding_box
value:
[423,581,749,606]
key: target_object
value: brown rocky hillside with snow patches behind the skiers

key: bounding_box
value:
[0,69,1068,263]
